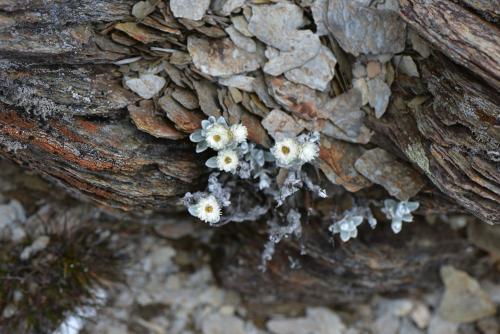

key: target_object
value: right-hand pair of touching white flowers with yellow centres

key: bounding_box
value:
[271,132,319,168]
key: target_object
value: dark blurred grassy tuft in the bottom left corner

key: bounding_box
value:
[0,219,120,334]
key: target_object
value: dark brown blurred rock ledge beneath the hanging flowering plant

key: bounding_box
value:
[214,217,477,305]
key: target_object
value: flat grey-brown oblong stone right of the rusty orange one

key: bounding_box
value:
[354,148,425,201]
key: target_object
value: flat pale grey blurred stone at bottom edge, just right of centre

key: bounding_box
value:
[267,307,346,334]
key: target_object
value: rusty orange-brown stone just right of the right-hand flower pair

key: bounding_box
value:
[319,137,372,192]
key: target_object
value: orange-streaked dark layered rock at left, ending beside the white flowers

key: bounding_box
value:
[0,103,203,211]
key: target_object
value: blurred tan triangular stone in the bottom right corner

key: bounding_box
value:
[438,266,496,323]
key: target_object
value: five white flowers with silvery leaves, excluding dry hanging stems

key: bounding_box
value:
[184,117,326,225]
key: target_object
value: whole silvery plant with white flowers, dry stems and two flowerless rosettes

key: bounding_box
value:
[184,117,418,270]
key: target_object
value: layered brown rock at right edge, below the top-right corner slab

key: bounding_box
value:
[368,56,500,224]
